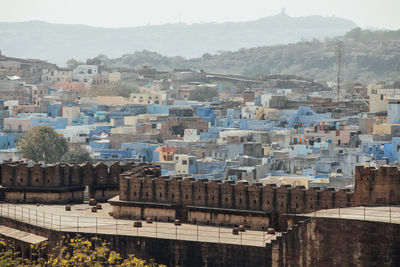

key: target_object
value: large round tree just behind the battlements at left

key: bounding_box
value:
[16,126,68,163]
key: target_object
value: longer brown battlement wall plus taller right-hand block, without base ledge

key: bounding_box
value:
[119,165,400,217]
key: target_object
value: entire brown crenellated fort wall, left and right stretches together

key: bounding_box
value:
[1,162,400,216]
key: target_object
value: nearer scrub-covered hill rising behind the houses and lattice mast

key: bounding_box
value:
[100,28,400,82]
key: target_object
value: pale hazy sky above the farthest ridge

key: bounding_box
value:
[0,0,400,29]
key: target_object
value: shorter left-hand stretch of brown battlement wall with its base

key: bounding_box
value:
[0,162,142,203]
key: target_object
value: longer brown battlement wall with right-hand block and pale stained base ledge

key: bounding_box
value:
[110,164,400,229]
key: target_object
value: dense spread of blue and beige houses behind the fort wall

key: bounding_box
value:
[0,53,400,192]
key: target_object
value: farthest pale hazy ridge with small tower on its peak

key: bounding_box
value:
[0,13,357,65]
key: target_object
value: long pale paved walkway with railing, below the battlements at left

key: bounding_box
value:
[0,203,280,247]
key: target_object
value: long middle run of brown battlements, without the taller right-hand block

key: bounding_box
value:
[119,165,364,217]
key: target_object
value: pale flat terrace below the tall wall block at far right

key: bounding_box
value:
[298,205,400,224]
